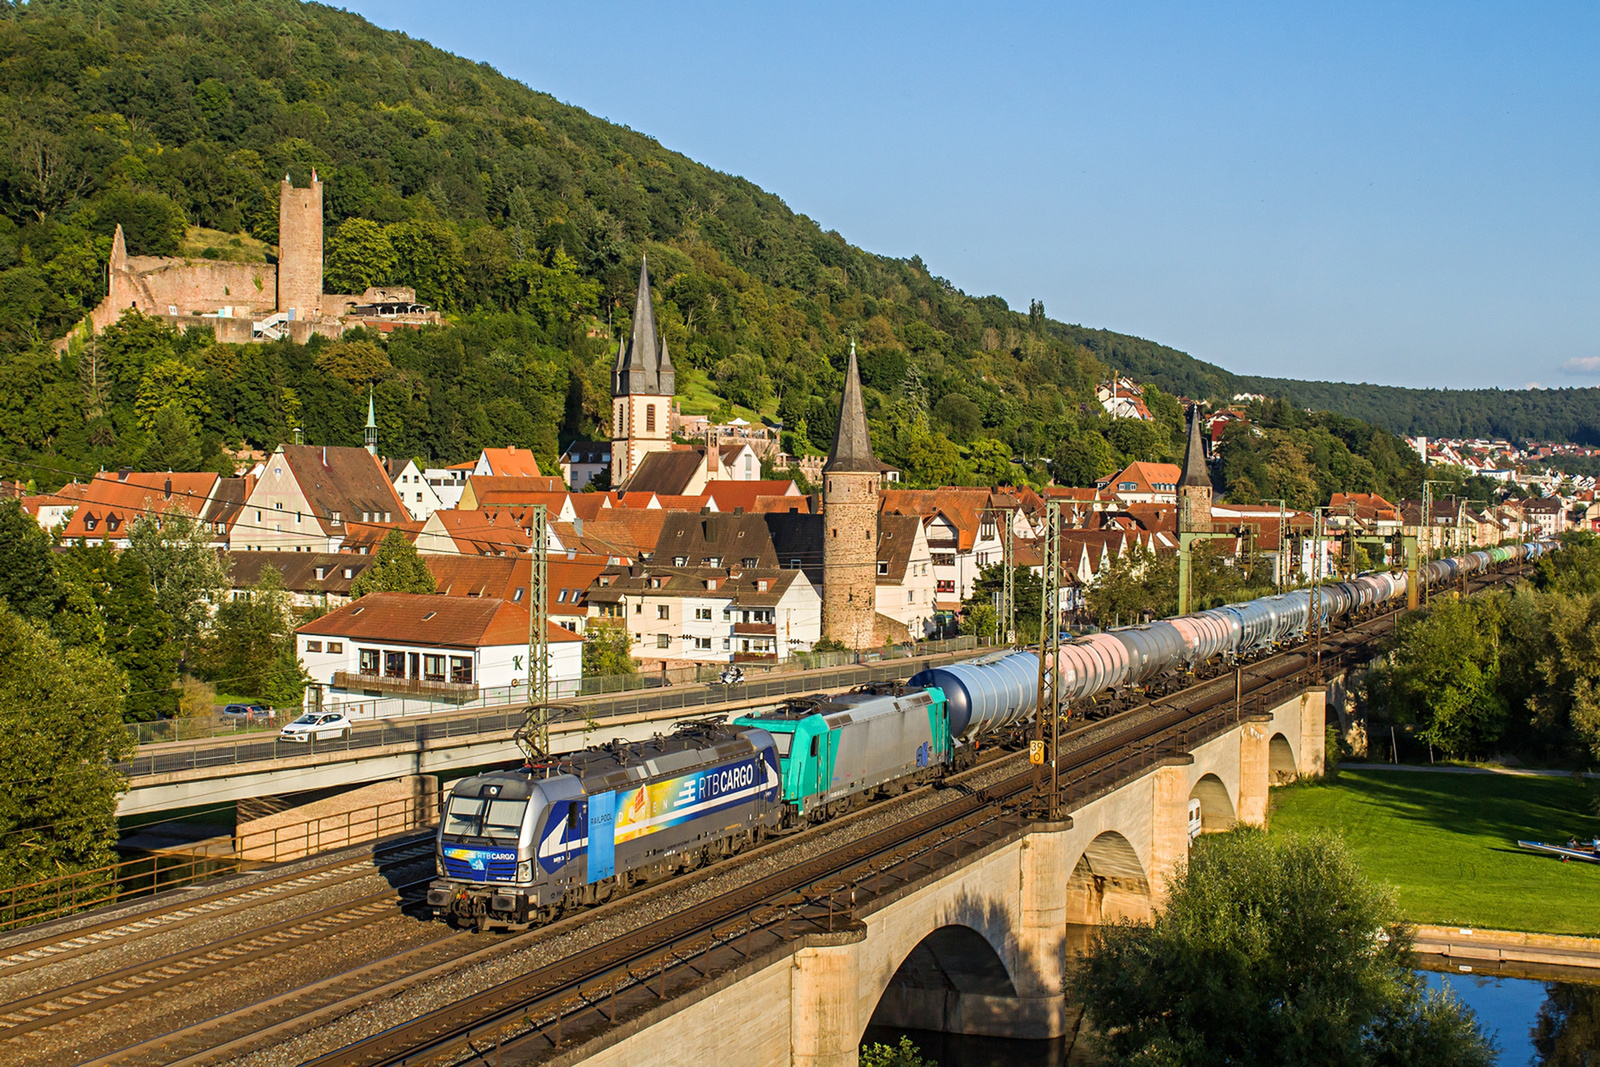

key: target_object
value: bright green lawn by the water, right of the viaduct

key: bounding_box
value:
[1270,769,1600,934]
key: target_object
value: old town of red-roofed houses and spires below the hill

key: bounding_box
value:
[22,264,1600,716]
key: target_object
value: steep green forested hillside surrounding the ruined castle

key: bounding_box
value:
[0,0,1548,496]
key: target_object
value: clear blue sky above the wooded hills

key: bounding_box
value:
[346,0,1600,387]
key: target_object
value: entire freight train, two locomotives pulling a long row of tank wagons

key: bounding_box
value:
[427,542,1550,929]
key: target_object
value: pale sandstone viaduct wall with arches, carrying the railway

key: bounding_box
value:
[569,686,1326,1067]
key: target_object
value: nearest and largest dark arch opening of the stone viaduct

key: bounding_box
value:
[867,923,1018,1035]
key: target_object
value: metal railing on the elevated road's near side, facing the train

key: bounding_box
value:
[117,638,973,777]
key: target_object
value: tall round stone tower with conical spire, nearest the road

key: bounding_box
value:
[822,344,880,648]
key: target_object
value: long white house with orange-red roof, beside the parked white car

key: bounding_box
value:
[294,593,584,705]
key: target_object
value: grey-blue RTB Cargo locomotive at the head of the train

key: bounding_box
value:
[427,725,784,929]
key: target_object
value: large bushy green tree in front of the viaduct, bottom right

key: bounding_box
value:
[1070,829,1494,1067]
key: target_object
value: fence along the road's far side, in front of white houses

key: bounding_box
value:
[126,637,994,745]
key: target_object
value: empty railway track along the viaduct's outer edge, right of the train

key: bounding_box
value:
[291,568,1525,1067]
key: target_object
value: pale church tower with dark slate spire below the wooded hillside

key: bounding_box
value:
[611,259,677,486]
